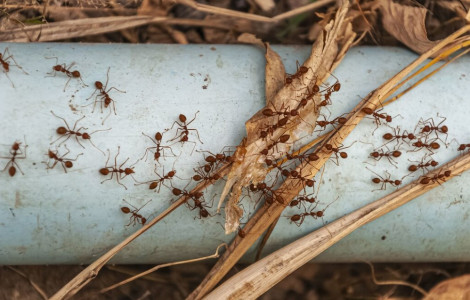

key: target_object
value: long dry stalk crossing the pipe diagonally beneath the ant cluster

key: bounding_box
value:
[188,25,470,299]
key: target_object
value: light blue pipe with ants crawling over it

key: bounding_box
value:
[0,43,470,264]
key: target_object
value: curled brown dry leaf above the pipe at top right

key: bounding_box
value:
[378,0,440,54]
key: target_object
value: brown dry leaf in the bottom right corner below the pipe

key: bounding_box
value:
[423,274,470,300]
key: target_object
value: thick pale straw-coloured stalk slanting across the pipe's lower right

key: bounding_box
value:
[204,152,470,300]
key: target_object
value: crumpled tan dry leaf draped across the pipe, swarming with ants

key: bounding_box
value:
[218,0,355,233]
